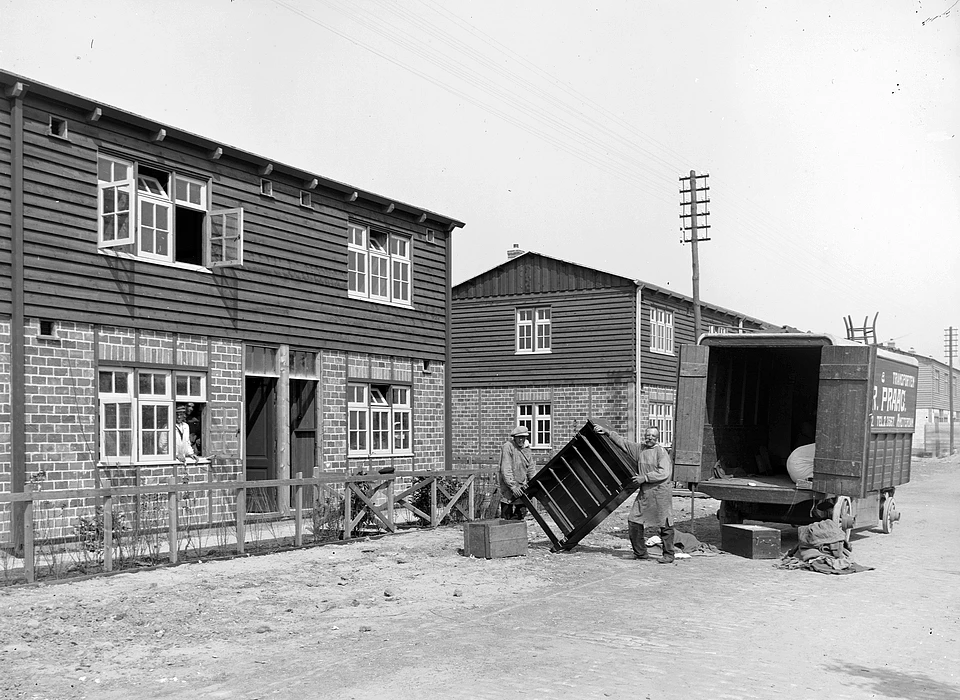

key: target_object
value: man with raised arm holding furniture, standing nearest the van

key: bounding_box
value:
[594,425,675,564]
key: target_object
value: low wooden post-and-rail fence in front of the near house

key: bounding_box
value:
[0,467,496,583]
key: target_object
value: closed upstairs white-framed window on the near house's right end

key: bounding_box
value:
[347,224,412,306]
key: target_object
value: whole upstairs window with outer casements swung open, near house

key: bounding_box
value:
[97,154,243,268]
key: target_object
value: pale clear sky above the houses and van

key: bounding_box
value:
[0,0,960,361]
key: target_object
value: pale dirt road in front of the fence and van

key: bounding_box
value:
[0,456,960,700]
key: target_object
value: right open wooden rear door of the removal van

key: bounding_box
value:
[813,345,875,497]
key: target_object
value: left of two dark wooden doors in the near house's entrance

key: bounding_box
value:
[244,377,277,513]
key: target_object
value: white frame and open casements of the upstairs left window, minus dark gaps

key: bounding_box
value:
[97,153,243,269]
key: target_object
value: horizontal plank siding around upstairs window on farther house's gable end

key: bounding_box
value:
[451,287,636,388]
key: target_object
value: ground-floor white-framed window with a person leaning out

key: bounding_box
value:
[98,367,207,464]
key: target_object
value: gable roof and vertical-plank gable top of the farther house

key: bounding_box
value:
[453,251,784,329]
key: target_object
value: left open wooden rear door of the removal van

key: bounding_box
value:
[673,345,713,483]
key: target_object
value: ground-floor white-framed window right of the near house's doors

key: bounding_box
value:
[347,383,413,456]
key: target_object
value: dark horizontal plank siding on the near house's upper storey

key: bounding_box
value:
[11,92,448,360]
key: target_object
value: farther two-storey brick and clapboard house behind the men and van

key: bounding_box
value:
[451,250,782,463]
